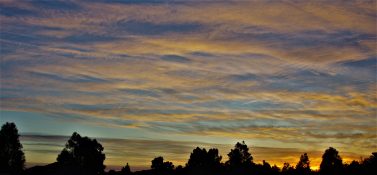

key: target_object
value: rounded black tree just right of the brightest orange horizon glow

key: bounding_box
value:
[320,147,343,175]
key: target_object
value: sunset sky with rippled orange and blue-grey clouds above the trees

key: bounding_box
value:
[0,0,377,172]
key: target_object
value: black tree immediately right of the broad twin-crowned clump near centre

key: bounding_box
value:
[227,141,253,168]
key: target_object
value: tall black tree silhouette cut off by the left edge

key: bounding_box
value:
[0,122,25,174]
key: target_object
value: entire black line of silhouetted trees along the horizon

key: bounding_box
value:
[0,123,377,175]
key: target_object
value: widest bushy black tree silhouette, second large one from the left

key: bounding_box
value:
[57,132,105,174]
